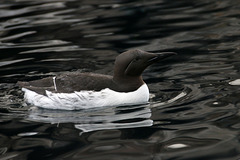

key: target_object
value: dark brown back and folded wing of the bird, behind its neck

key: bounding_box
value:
[18,72,114,94]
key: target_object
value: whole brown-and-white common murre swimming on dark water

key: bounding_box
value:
[18,49,176,110]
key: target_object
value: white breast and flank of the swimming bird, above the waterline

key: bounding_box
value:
[22,84,149,110]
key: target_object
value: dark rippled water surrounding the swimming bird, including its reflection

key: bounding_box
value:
[0,0,240,160]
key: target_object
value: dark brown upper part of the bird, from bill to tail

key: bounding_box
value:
[18,50,176,94]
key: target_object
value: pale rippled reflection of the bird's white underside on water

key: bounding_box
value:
[28,105,153,132]
